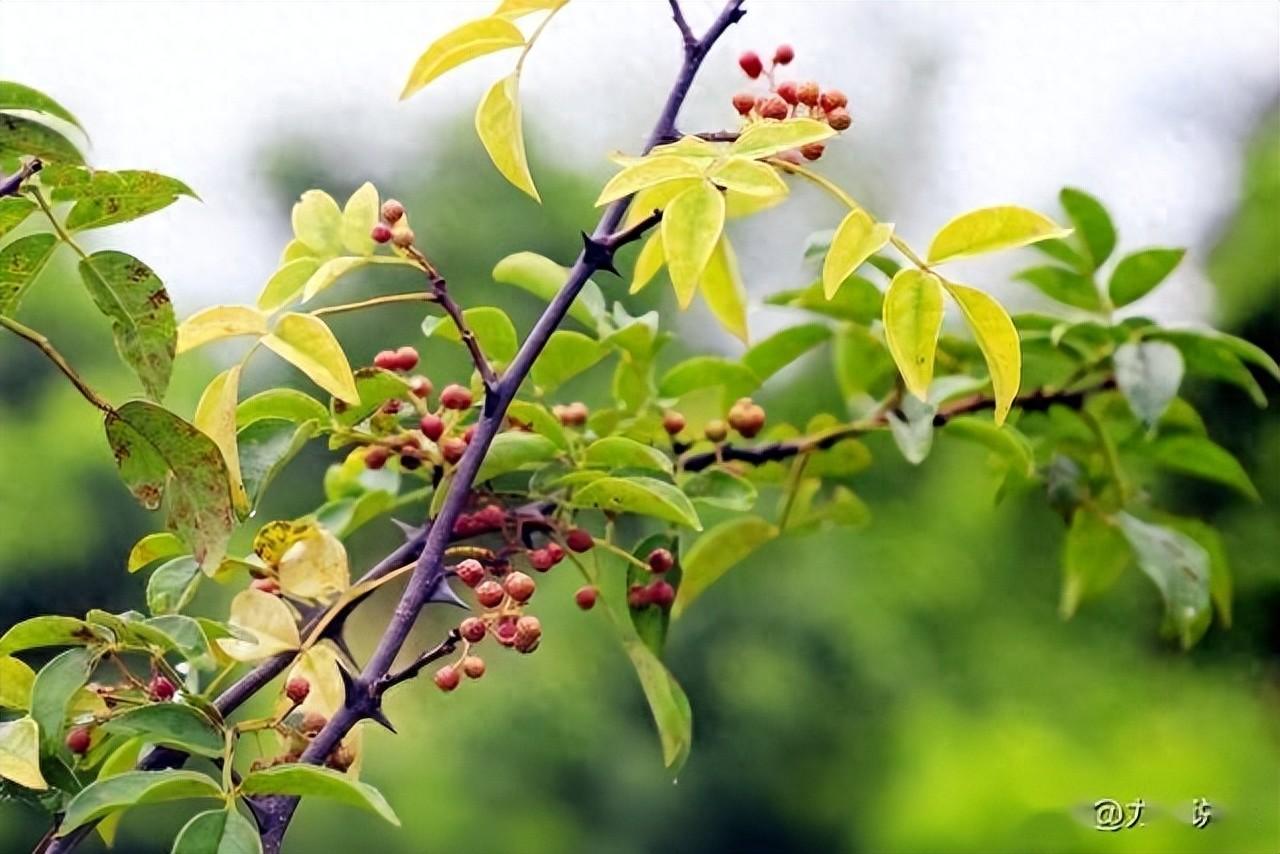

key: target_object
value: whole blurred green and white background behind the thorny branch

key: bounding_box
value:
[0,0,1280,854]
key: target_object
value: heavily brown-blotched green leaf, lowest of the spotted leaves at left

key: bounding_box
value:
[106,401,236,572]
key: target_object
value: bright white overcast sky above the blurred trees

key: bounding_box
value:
[0,0,1280,332]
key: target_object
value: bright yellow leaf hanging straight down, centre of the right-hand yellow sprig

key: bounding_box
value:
[883,268,942,401]
